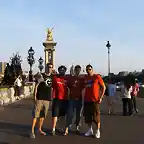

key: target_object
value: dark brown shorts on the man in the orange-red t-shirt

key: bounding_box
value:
[84,102,100,123]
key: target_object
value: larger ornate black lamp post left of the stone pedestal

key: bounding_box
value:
[27,47,35,82]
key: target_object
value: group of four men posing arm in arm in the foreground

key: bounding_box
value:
[30,63,105,138]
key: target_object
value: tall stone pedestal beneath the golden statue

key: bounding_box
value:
[43,41,57,72]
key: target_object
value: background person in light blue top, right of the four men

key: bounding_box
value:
[107,81,116,114]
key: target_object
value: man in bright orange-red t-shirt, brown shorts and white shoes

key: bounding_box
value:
[83,64,106,138]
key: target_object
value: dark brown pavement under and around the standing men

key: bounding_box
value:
[0,99,144,144]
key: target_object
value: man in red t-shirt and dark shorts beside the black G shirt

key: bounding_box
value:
[52,65,69,135]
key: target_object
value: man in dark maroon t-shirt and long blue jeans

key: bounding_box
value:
[65,65,82,135]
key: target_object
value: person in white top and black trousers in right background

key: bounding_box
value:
[122,83,133,116]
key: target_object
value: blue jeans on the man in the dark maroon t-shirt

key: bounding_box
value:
[66,100,82,127]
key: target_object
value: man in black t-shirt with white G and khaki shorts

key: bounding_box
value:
[30,63,53,138]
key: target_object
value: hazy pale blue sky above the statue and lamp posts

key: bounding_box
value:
[0,0,144,74]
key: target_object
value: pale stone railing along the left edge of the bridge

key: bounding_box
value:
[0,83,34,105]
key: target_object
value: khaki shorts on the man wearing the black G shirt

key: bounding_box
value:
[33,100,50,118]
